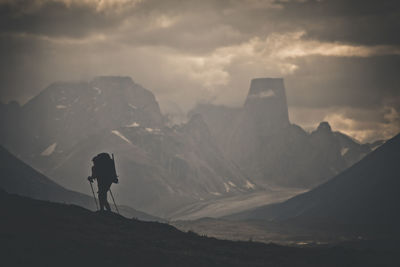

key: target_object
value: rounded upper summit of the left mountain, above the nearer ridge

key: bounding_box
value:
[13,77,163,155]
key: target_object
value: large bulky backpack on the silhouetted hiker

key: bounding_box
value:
[92,153,118,183]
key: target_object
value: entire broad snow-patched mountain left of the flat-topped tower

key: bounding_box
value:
[2,77,261,217]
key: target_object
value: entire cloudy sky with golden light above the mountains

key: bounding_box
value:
[0,0,400,141]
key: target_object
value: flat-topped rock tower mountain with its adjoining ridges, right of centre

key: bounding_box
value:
[192,78,371,188]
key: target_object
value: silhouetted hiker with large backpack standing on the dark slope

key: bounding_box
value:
[88,153,118,211]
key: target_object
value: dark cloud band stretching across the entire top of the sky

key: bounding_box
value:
[0,0,400,52]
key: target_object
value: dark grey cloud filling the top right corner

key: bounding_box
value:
[281,0,400,45]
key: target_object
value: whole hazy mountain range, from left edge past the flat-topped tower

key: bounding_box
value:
[0,76,382,218]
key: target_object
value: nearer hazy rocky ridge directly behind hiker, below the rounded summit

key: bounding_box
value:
[43,113,260,217]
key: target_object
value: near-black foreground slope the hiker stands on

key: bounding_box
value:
[0,190,398,267]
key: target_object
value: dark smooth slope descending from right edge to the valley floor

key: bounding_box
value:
[228,134,400,227]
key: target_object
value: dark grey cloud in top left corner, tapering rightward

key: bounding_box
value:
[0,0,123,38]
